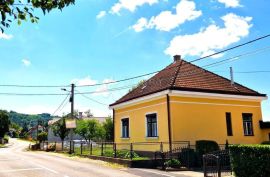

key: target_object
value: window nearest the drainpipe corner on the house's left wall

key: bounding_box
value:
[146,114,158,137]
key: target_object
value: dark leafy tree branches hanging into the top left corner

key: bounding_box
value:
[0,0,75,33]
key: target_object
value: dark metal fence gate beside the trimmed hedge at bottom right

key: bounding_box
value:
[203,150,232,177]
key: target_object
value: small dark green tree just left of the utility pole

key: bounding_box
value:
[52,117,69,141]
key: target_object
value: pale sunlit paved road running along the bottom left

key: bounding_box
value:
[0,139,200,177]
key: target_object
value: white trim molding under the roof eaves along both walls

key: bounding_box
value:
[110,90,268,109]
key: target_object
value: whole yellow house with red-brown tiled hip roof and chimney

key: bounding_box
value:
[110,55,270,151]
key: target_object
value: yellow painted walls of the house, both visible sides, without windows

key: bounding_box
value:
[115,96,270,151]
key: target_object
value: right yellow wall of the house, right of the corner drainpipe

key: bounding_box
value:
[171,96,265,144]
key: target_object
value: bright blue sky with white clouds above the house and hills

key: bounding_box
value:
[0,0,270,120]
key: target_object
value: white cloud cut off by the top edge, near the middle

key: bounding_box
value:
[110,0,158,14]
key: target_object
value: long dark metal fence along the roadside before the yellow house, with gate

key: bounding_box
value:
[40,141,230,171]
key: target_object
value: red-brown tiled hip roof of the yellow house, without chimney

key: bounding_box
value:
[111,60,266,106]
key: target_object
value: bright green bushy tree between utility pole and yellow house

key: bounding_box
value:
[75,120,105,142]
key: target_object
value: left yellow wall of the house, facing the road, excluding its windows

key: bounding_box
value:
[114,97,168,150]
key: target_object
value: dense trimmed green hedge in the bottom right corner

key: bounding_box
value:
[229,145,270,177]
